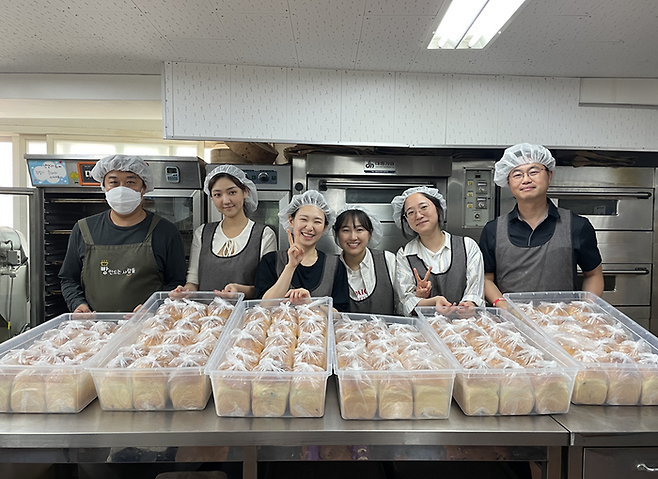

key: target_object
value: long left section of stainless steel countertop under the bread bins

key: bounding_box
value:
[0,378,564,448]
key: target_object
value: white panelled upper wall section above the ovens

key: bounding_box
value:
[163,62,658,150]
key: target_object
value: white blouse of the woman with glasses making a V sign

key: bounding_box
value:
[396,231,484,316]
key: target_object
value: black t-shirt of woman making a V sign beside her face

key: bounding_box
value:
[254,251,350,312]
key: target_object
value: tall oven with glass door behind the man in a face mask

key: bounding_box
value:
[25,155,206,323]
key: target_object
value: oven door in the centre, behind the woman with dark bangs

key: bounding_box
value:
[308,177,448,253]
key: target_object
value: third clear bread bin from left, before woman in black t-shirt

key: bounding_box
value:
[206,297,333,417]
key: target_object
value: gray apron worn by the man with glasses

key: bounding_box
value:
[496,208,575,293]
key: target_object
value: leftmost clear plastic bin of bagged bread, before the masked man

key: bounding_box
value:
[0,313,127,413]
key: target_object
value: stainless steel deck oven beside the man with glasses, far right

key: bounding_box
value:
[501,166,658,329]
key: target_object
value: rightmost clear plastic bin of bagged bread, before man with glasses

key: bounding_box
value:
[504,291,658,405]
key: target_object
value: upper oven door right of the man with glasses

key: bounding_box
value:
[548,186,653,231]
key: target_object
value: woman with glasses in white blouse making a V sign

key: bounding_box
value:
[391,186,484,316]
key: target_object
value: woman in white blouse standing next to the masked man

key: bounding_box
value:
[174,165,276,299]
